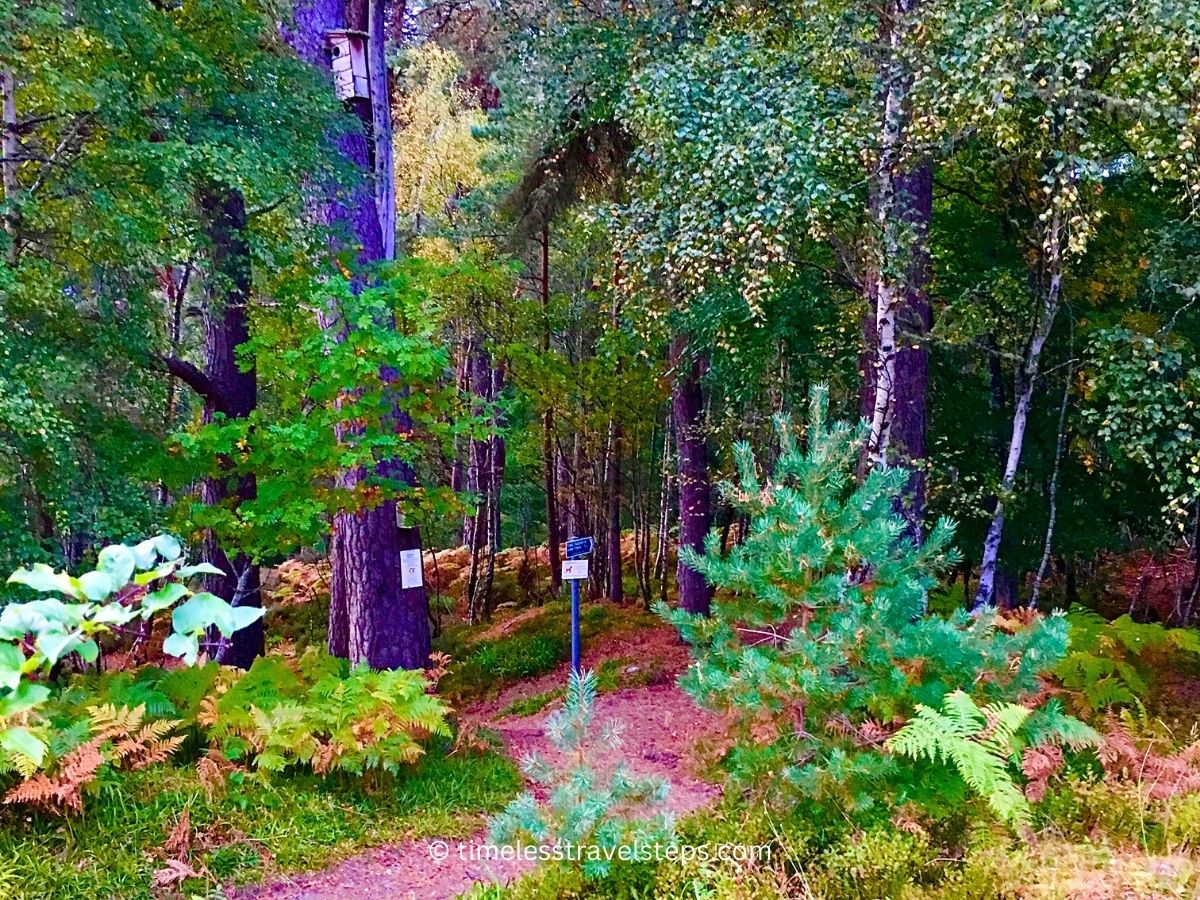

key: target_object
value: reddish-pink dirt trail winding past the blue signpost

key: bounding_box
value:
[229,628,720,900]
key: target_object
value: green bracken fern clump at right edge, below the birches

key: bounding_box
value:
[1054,606,1200,714]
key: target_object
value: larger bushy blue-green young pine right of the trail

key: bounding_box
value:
[660,390,1084,821]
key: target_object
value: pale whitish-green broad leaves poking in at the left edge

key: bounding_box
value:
[0,535,263,782]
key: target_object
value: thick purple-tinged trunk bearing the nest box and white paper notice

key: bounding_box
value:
[283,0,430,668]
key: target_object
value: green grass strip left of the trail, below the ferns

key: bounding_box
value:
[0,745,521,900]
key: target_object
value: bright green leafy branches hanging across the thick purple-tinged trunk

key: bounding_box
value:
[158,259,482,560]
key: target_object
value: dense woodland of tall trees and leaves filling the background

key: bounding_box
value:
[7,0,1200,643]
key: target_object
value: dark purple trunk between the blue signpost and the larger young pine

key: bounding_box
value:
[671,335,713,616]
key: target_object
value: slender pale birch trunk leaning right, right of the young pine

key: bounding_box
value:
[973,211,1063,610]
